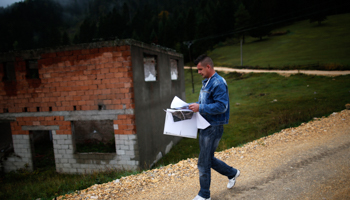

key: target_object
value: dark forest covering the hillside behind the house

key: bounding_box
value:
[0,0,350,61]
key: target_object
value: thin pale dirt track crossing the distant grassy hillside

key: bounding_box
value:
[184,66,350,76]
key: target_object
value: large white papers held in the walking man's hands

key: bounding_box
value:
[164,96,210,139]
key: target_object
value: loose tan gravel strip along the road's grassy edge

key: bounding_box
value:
[57,110,350,200]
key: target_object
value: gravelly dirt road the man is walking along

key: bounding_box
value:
[58,110,350,200]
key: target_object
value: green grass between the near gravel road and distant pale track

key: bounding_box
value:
[154,70,350,166]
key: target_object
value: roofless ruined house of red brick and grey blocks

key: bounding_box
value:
[0,40,185,173]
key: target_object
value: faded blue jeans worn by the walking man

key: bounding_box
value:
[198,125,237,199]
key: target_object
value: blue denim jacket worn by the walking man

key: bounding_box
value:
[197,72,230,126]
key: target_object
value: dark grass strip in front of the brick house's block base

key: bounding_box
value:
[0,167,138,200]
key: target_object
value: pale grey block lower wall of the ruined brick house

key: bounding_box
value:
[5,130,139,174]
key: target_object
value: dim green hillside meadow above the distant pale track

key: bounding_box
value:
[208,13,350,70]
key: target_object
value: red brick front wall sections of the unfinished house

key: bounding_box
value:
[0,45,135,134]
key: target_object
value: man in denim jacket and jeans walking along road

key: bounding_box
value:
[189,55,240,200]
